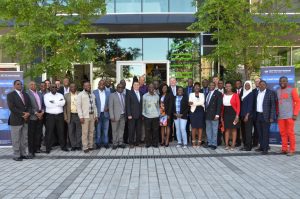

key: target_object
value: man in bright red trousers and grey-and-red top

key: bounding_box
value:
[277,76,300,156]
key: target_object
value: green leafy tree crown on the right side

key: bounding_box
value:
[189,0,299,78]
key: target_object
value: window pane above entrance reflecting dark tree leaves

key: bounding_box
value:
[118,38,142,60]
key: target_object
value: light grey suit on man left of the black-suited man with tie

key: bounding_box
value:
[109,92,125,146]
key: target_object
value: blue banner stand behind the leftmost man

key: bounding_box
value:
[0,71,23,146]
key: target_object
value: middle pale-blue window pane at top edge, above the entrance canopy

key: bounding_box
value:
[143,0,168,12]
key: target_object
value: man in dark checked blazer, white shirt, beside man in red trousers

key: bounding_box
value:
[255,80,276,155]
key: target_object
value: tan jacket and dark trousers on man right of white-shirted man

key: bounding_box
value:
[64,92,82,148]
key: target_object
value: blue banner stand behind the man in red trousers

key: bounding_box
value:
[260,66,295,144]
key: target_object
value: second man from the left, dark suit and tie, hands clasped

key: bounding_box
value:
[27,81,45,157]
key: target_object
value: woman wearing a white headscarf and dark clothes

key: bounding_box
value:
[241,81,254,151]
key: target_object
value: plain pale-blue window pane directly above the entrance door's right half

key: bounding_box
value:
[143,38,168,60]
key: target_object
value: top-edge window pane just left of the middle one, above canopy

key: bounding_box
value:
[116,0,142,13]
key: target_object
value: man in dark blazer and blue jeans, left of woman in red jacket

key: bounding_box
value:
[205,82,223,150]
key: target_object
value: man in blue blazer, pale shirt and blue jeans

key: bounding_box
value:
[93,80,110,149]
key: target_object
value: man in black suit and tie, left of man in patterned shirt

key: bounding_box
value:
[126,82,143,148]
